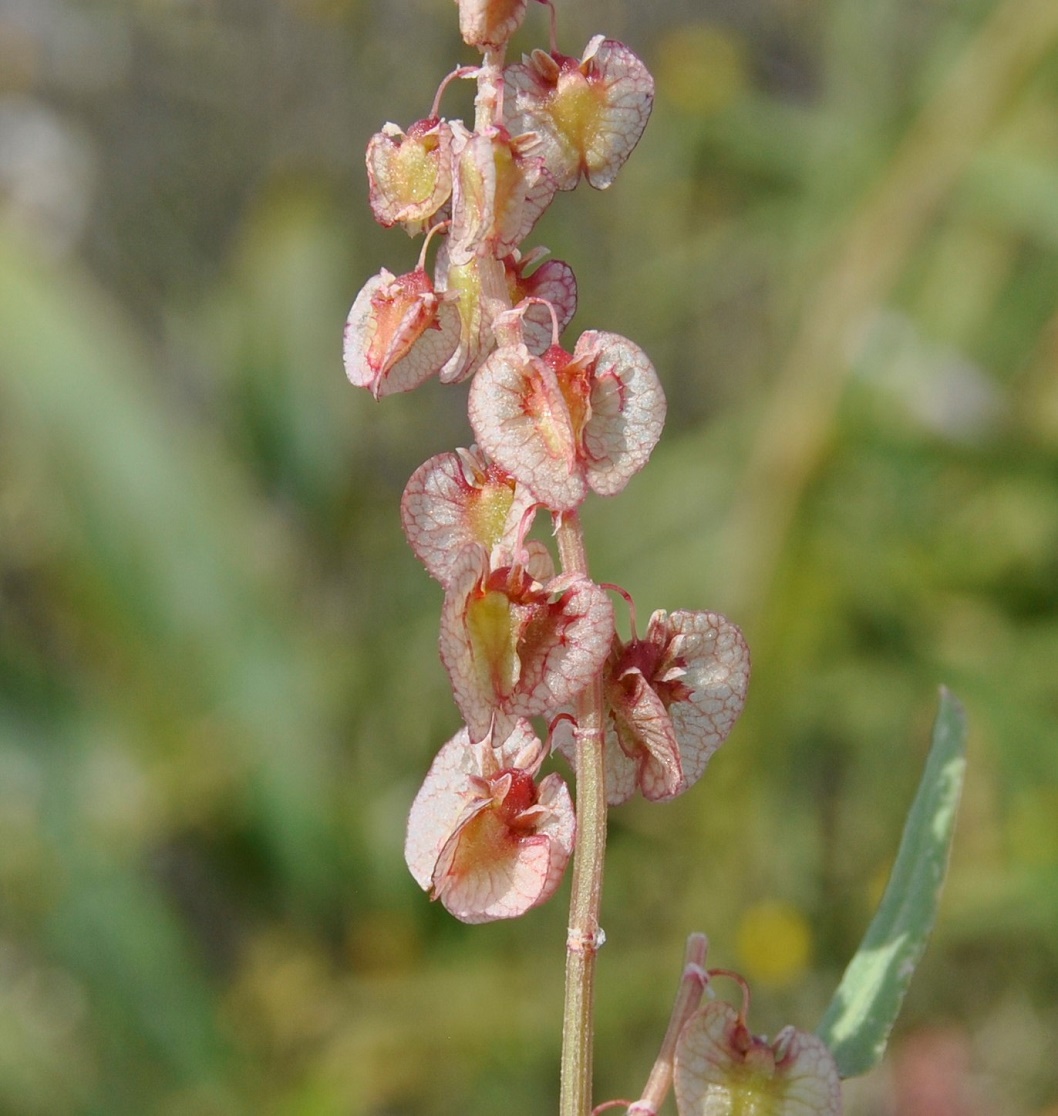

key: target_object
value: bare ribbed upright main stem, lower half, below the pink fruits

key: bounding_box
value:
[557,512,606,1116]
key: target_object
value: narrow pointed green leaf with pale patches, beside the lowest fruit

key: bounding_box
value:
[817,687,966,1077]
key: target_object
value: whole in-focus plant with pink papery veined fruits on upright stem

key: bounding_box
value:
[344,0,961,1116]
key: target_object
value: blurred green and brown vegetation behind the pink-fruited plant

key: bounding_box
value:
[0,0,1058,1116]
